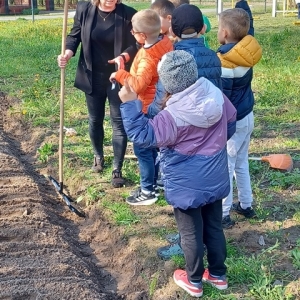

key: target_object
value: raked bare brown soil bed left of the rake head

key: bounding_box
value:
[0,93,120,300]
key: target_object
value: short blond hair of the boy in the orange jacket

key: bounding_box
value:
[131,9,161,37]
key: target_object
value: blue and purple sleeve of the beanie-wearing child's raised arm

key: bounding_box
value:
[120,100,177,148]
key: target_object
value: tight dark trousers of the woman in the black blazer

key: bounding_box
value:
[85,73,127,170]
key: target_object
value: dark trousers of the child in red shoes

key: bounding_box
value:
[174,200,226,282]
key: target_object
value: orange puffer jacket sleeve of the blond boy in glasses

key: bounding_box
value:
[116,58,156,94]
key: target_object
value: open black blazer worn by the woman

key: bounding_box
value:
[66,1,137,94]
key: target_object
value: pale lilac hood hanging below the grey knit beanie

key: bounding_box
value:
[165,77,224,128]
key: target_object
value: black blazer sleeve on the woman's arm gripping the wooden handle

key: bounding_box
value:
[66,2,87,56]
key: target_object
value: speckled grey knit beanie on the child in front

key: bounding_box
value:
[157,50,198,95]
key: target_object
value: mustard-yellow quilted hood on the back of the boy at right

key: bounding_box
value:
[218,35,262,68]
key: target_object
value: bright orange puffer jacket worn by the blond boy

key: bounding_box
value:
[115,36,173,113]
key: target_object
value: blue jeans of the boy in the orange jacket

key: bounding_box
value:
[133,144,158,192]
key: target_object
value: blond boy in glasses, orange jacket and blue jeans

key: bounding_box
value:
[110,9,173,205]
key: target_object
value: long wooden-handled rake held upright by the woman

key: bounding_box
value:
[48,0,85,218]
